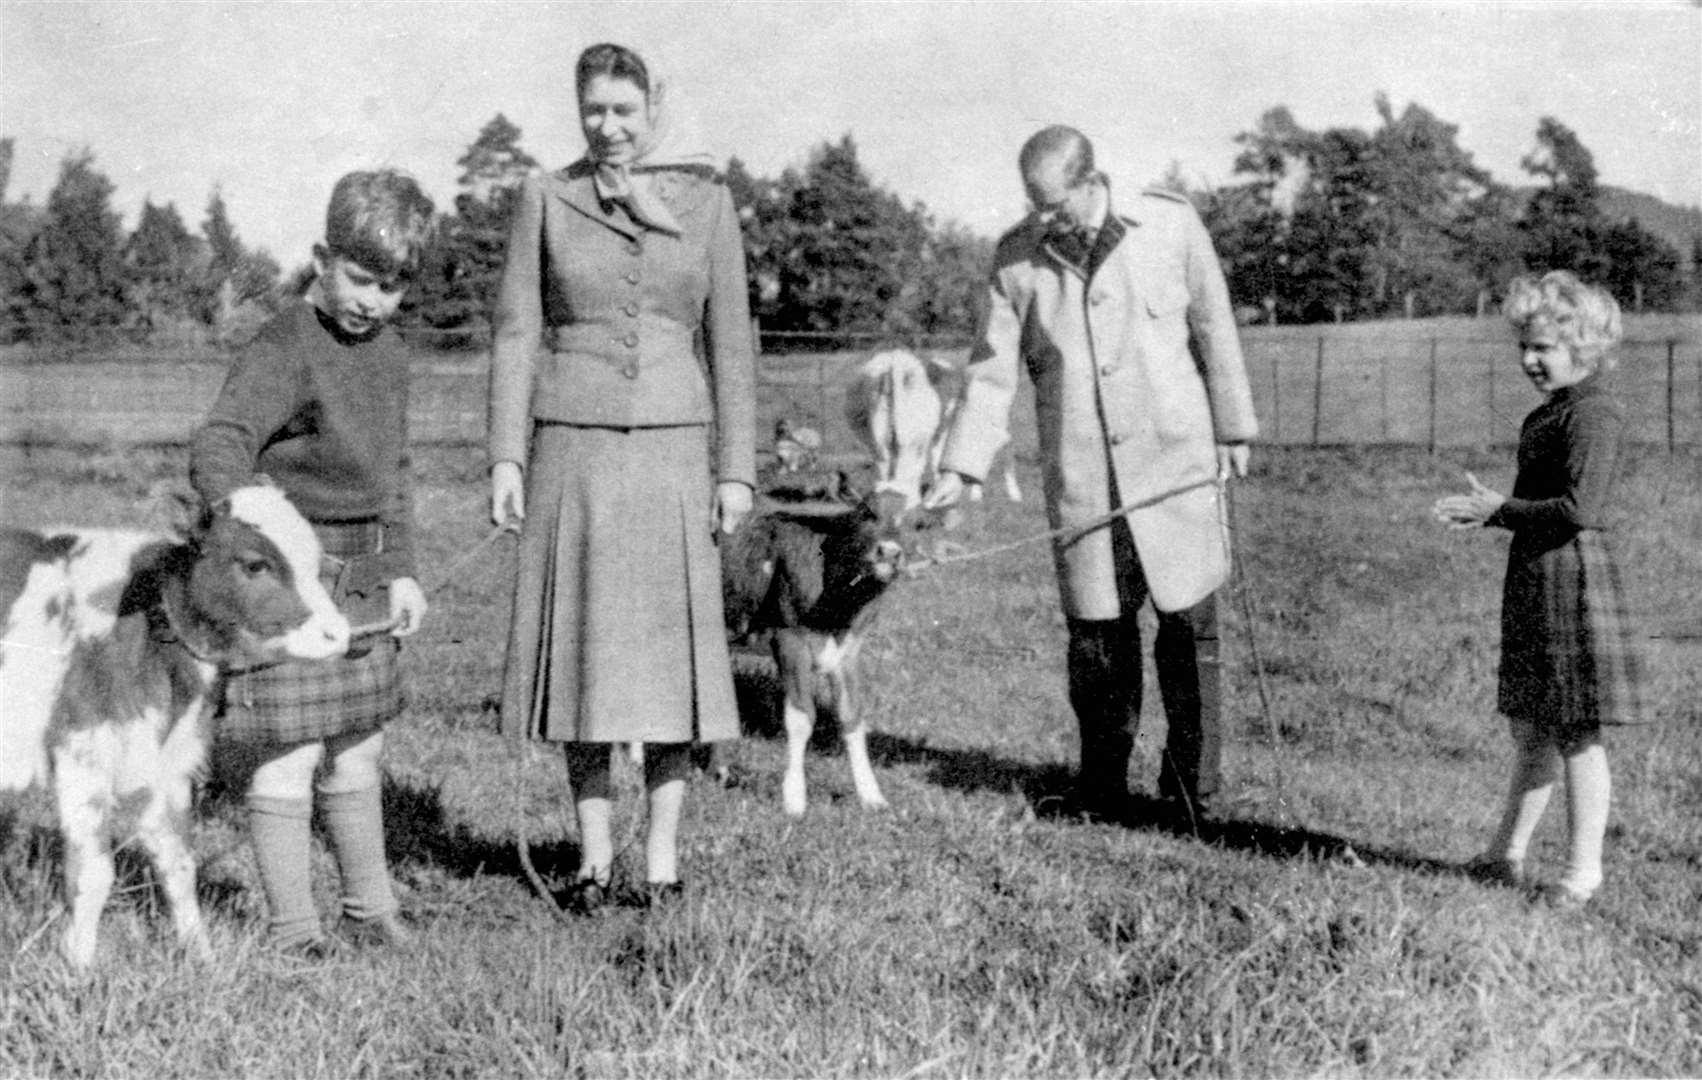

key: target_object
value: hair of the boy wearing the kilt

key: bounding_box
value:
[325,168,434,277]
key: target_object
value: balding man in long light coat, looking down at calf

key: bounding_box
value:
[928,128,1258,820]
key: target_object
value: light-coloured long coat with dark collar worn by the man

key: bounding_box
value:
[941,190,1258,619]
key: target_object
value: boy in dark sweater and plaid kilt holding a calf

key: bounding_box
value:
[189,170,432,956]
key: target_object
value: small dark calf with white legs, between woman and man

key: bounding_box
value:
[722,492,904,815]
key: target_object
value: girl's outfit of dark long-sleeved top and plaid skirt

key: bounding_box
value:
[1486,372,1644,736]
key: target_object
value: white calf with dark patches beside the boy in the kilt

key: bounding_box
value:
[0,486,349,966]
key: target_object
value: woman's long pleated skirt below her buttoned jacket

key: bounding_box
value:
[502,423,739,743]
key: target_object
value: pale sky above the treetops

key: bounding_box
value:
[0,0,1702,269]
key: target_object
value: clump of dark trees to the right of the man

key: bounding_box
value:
[1198,95,1702,323]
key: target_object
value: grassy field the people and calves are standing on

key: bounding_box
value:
[0,449,1702,1078]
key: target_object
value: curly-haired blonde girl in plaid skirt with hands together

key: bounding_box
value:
[1435,270,1642,908]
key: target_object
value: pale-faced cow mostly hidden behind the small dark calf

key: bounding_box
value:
[846,349,1023,509]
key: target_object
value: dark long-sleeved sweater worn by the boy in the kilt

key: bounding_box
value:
[189,303,417,580]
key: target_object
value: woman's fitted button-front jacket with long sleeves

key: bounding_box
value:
[490,162,756,483]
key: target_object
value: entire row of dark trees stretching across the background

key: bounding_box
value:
[0,97,1702,347]
